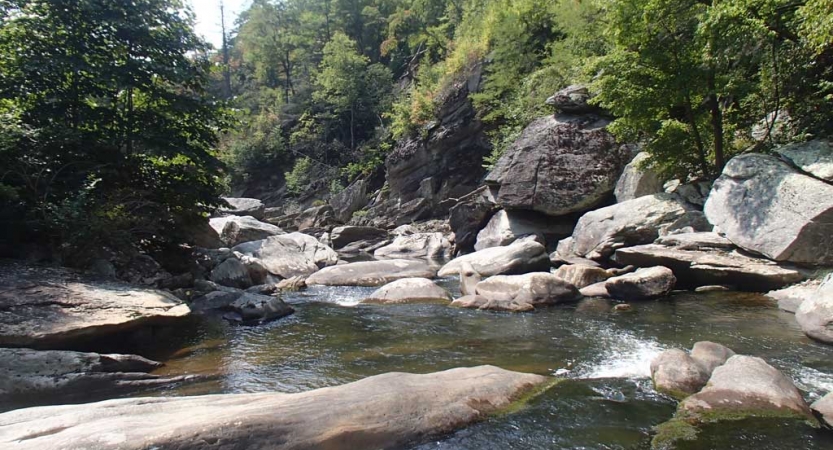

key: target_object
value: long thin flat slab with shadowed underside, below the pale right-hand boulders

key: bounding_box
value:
[613,244,804,292]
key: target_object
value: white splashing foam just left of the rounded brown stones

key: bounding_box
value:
[577,331,665,378]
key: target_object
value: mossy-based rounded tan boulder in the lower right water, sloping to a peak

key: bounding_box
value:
[679,355,814,421]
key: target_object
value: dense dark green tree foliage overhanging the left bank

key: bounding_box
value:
[0,0,226,256]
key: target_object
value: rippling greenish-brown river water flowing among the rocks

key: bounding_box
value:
[122,279,833,450]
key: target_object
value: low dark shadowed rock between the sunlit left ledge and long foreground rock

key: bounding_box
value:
[0,348,192,404]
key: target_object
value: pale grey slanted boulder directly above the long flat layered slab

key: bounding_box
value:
[558,194,702,260]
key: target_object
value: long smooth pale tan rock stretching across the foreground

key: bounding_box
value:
[0,366,550,450]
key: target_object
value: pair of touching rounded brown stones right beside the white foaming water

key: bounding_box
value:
[651,341,735,399]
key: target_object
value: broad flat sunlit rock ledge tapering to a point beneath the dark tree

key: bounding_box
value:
[0,261,191,348]
